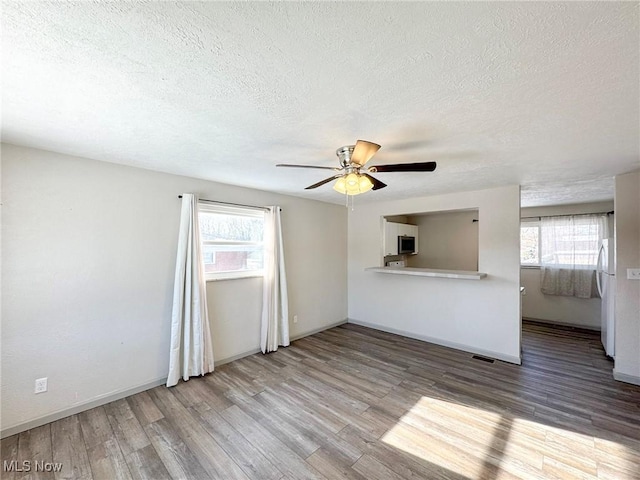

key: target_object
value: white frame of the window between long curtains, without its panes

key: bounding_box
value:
[198,201,266,282]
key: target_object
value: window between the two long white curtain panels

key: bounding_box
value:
[198,203,264,280]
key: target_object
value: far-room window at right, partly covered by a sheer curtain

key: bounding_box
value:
[520,215,606,269]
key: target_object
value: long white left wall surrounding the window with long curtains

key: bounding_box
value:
[1,145,347,432]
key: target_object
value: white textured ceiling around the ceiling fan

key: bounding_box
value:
[2,0,640,206]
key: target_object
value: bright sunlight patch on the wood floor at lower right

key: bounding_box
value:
[382,396,640,479]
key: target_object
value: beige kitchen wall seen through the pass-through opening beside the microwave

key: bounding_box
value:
[408,210,478,271]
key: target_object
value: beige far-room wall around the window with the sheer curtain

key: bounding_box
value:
[521,201,613,330]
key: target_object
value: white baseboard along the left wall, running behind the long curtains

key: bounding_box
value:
[0,318,347,438]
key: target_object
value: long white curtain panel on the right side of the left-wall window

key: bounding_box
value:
[260,207,289,353]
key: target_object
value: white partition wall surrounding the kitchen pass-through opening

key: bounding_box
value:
[349,186,520,362]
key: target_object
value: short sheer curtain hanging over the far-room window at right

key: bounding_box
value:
[540,215,607,298]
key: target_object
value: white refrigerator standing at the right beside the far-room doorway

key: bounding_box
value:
[596,238,616,358]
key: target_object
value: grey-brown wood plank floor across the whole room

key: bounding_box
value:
[2,323,640,480]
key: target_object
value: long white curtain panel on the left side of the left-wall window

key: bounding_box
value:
[167,193,213,387]
